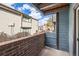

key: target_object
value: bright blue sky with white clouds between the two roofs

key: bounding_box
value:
[2,3,52,26]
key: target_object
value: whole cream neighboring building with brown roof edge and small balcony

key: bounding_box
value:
[0,4,38,35]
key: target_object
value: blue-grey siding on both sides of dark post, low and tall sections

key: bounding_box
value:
[45,7,69,52]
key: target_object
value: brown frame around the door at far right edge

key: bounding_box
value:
[73,4,79,56]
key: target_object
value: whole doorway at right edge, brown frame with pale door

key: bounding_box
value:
[73,4,79,56]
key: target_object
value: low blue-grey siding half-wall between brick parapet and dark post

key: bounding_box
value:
[45,32,56,48]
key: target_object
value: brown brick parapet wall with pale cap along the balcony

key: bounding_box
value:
[0,33,44,56]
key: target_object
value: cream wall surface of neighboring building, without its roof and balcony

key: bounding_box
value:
[0,9,38,35]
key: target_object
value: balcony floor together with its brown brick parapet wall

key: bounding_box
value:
[0,33,69,56]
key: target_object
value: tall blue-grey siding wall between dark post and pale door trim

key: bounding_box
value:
[59,7,69,51]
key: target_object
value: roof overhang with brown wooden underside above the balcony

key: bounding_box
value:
[33,3,69,14]
